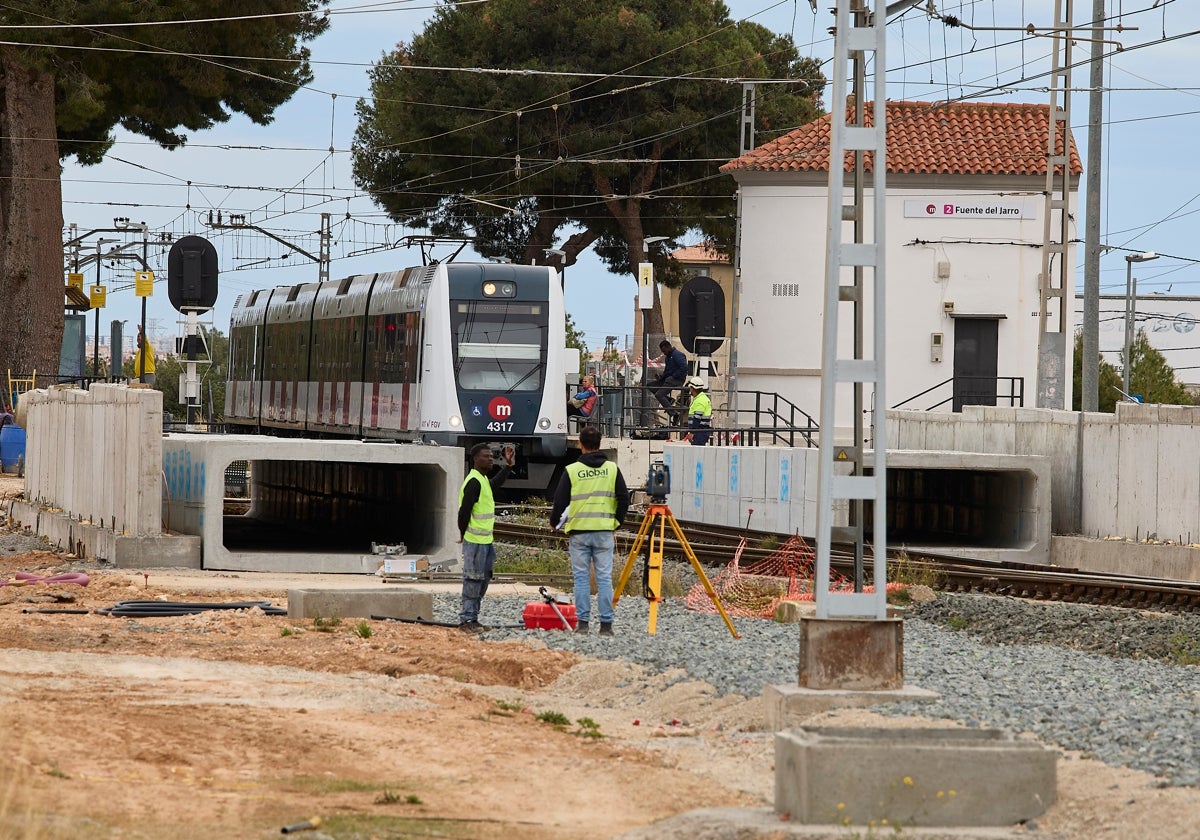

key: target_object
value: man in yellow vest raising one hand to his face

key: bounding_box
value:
[458,443,516,632]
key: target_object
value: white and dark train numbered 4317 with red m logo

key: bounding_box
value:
[226,263,568,490]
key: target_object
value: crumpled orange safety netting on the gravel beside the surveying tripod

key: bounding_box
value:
[685,535,904,618]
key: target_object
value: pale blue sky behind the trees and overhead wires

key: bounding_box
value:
[62,0,1200,362]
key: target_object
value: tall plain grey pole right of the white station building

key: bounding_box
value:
[1079,0,1104,412]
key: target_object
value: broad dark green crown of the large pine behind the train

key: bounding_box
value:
[353,0,824,328]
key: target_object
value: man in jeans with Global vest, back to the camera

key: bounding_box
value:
[550,426,629,636]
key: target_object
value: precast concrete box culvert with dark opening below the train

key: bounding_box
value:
[162,434,464,574]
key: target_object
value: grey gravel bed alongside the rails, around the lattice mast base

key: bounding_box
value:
[451,593,1200,786]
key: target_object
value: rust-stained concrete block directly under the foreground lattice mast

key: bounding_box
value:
[799,617,904,691]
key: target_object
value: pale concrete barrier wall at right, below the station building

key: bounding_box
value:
[888,403,1200,544]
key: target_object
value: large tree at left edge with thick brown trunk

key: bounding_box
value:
[0,0,329,380]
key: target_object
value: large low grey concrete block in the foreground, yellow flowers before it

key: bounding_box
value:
[775,727,1057,827]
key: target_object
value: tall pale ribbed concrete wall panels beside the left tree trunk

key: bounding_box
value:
[20,384,162,536]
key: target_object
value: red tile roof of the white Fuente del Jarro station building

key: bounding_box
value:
[721,102,1084,175]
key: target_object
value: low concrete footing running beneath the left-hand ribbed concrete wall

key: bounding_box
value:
[12,500,200,569]
